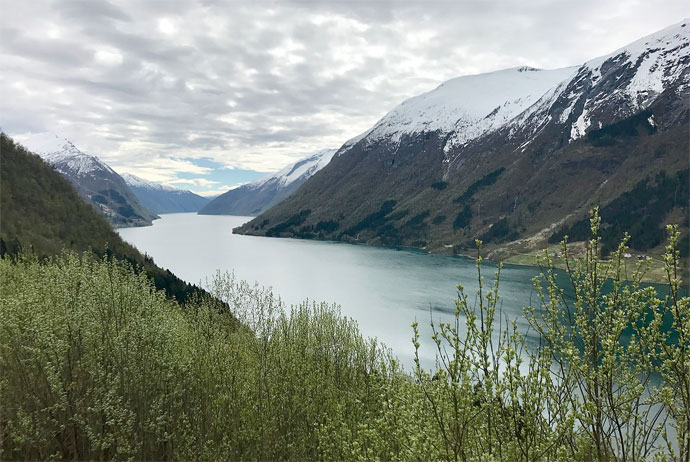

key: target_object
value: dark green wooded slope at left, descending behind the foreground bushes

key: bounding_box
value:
[0,132,210,302]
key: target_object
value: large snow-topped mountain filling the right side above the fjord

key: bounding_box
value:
[235,20,690,258]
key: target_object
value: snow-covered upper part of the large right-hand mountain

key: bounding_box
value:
[339,19,690,156]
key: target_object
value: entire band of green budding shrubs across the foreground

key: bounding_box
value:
[0,216,690,461]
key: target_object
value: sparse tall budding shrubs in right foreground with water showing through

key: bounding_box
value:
[400,215,690,461]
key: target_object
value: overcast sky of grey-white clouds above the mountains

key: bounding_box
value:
[0,0,690,194]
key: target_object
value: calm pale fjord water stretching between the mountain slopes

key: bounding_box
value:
[118,213,560,366]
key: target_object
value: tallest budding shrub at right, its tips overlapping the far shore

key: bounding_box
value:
[528,210,667,460]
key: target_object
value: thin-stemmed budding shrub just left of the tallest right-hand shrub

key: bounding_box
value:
[404,242,573,461]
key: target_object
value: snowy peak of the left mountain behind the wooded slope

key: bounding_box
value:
[21,133,115,176]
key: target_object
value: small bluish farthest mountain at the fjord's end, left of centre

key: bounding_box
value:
[122,173,210,213]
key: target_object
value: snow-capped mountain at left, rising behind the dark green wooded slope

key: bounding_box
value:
[17,133,158,226]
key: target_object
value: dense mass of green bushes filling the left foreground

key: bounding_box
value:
[0,254,394,460]
